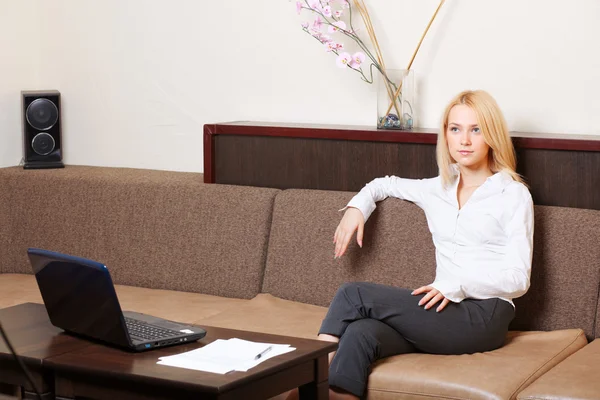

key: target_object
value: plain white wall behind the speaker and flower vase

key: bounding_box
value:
[0,0,600,171]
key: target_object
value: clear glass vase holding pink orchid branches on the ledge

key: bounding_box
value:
[377,69,415,129]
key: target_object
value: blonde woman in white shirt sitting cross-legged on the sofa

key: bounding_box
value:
[291,91,533,399]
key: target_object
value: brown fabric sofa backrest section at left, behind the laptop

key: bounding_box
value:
[0,166,279,298]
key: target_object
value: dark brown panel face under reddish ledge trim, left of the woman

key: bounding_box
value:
[215,135,437,191]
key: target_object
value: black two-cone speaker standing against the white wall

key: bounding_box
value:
[21,90,64,169]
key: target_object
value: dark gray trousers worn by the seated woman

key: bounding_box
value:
[319,282,515,397]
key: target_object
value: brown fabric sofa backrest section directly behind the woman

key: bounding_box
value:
[262,189,600,339]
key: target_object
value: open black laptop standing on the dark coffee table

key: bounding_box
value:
[27,248,206,351]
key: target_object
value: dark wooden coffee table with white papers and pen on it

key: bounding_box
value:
[44,318,337,400]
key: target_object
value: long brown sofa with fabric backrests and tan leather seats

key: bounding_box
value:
[0,166,600,399]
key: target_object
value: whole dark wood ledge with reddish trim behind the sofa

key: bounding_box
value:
[204,122,600,209]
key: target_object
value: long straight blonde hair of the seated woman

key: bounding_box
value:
[436,90,524,186]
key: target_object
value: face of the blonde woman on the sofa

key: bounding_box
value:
[446,104,490,170]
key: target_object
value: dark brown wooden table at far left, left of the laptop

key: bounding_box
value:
[0,303,90,399]
